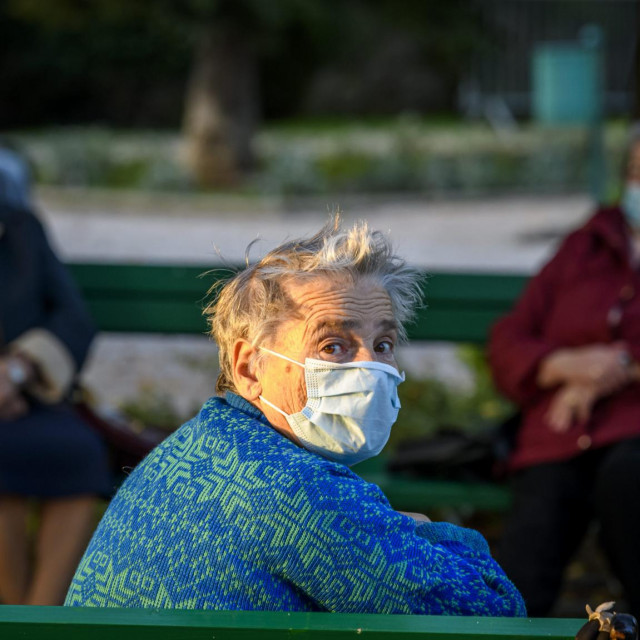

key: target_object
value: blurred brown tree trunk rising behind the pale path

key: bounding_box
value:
[183,27,258,187]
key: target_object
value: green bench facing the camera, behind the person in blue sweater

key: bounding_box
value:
[70,264,527,511]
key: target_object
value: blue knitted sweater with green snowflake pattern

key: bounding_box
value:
[65,394,525,616]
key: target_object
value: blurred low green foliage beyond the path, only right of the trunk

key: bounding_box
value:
[258,117,624,196]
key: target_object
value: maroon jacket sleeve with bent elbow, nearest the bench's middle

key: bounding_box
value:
[489,234,581,406]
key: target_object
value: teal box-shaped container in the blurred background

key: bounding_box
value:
[532,43,602,125]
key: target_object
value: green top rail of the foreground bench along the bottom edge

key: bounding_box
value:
[0,606,584,640]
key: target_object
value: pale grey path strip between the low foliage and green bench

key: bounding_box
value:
[38,191,590,271]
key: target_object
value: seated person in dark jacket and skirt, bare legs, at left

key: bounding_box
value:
[0,149,111,605]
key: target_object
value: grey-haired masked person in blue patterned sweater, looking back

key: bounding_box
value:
[66,223,525,616]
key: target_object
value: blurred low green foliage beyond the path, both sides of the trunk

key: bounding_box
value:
[13,117,626,197]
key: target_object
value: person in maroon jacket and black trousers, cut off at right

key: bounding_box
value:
[489,135,640,617]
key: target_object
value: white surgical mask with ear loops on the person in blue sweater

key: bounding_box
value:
[260,347,404,465]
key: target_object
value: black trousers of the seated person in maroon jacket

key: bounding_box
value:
[497,438,640,619]
